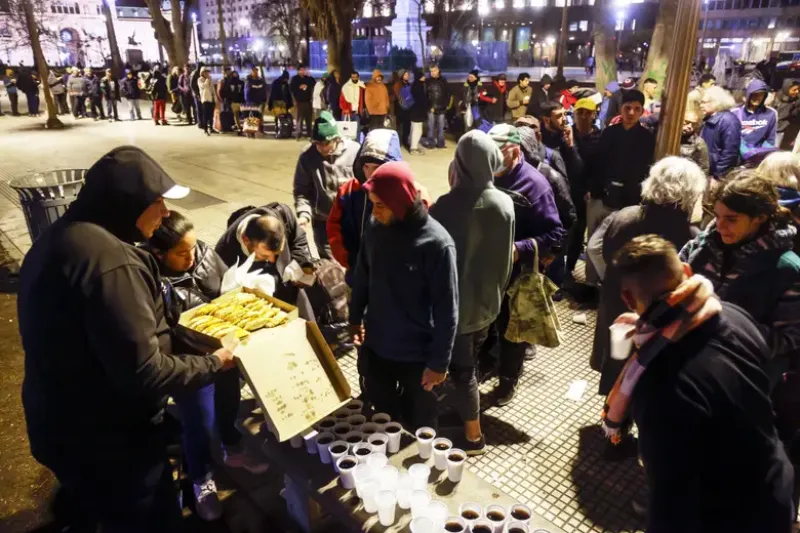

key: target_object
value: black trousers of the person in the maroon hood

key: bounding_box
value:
[361,344,438,429]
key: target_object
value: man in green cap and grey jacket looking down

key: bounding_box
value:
[294,111,359,259]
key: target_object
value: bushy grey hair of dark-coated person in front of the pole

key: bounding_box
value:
[642,156,706,214]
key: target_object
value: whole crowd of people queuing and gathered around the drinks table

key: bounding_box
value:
[12,58,800,533]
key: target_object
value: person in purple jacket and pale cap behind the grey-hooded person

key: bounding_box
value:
[482,124,565,407]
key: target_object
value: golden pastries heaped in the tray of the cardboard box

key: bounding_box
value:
[178,287,297,351]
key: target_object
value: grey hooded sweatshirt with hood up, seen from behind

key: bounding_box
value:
[430,130,514,335]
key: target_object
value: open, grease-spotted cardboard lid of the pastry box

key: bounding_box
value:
[235,318,351,442]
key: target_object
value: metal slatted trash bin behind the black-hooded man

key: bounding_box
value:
[8,168,88,242]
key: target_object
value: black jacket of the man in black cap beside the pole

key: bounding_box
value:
[588,124,656,209]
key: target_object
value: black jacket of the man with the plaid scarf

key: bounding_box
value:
[631,303,793,533]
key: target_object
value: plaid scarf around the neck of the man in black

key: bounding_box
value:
[602,275,722,444]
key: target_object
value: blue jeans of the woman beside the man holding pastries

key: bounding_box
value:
[175,370,242,484]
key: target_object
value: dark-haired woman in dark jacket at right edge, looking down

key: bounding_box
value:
[680,170,800,376]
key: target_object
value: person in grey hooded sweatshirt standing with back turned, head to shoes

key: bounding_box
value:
[430,130,514,455]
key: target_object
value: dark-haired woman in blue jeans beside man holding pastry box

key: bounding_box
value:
[145,211,267,521]
